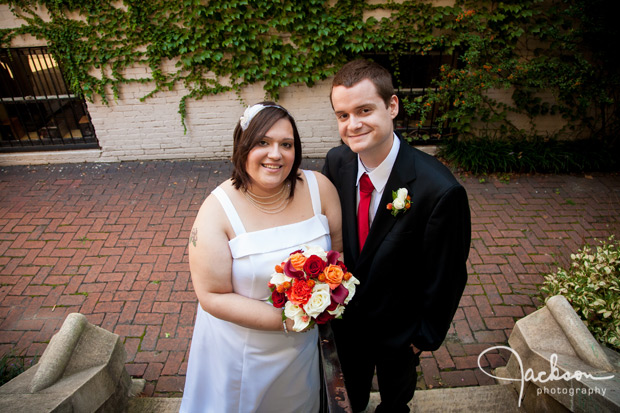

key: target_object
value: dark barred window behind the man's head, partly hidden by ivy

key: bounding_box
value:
[366,53,457,145]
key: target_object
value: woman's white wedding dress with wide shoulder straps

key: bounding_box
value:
[180,171,331,413]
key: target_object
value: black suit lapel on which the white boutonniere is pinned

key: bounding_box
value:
[358,141,416,265]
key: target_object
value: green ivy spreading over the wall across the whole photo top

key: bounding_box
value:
[0,0,620,141]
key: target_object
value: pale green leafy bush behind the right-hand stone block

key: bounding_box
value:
[541,236,620,351]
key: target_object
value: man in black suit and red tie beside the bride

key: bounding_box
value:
[323,60,471,412]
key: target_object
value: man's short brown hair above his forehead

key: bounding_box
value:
[330,59,394,108]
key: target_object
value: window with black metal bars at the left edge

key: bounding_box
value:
[0,47,99,152]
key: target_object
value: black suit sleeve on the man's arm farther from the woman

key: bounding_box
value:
[411,185,471,351]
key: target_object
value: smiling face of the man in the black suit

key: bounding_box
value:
[331,79,398,168]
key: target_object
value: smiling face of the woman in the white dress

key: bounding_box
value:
[245,118,295,195]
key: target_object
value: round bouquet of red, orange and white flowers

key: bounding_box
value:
[269,246,359,331]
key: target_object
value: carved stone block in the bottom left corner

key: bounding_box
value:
[0,313,132,413]
